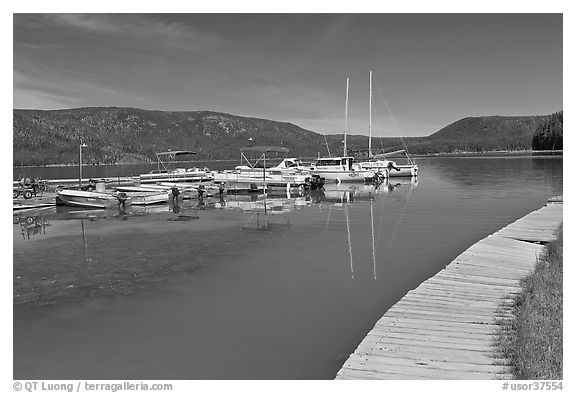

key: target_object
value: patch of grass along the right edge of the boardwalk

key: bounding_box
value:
[498,222,563,379]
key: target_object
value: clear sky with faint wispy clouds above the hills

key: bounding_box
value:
[13,13,563,137]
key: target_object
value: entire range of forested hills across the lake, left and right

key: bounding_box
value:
[13,107,560,165]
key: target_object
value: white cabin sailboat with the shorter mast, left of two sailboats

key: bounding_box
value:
[310,78,376,183]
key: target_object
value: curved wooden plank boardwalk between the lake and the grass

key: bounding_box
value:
[336,197,563,379]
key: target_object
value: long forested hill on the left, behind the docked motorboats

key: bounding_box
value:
[14,108,326,165]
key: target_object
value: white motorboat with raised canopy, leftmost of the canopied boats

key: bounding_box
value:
[140,150,213,184]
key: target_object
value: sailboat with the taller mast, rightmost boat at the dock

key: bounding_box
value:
[359,71,418,177]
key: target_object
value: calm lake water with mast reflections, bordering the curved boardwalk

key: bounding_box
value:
[13,157,563,380]
